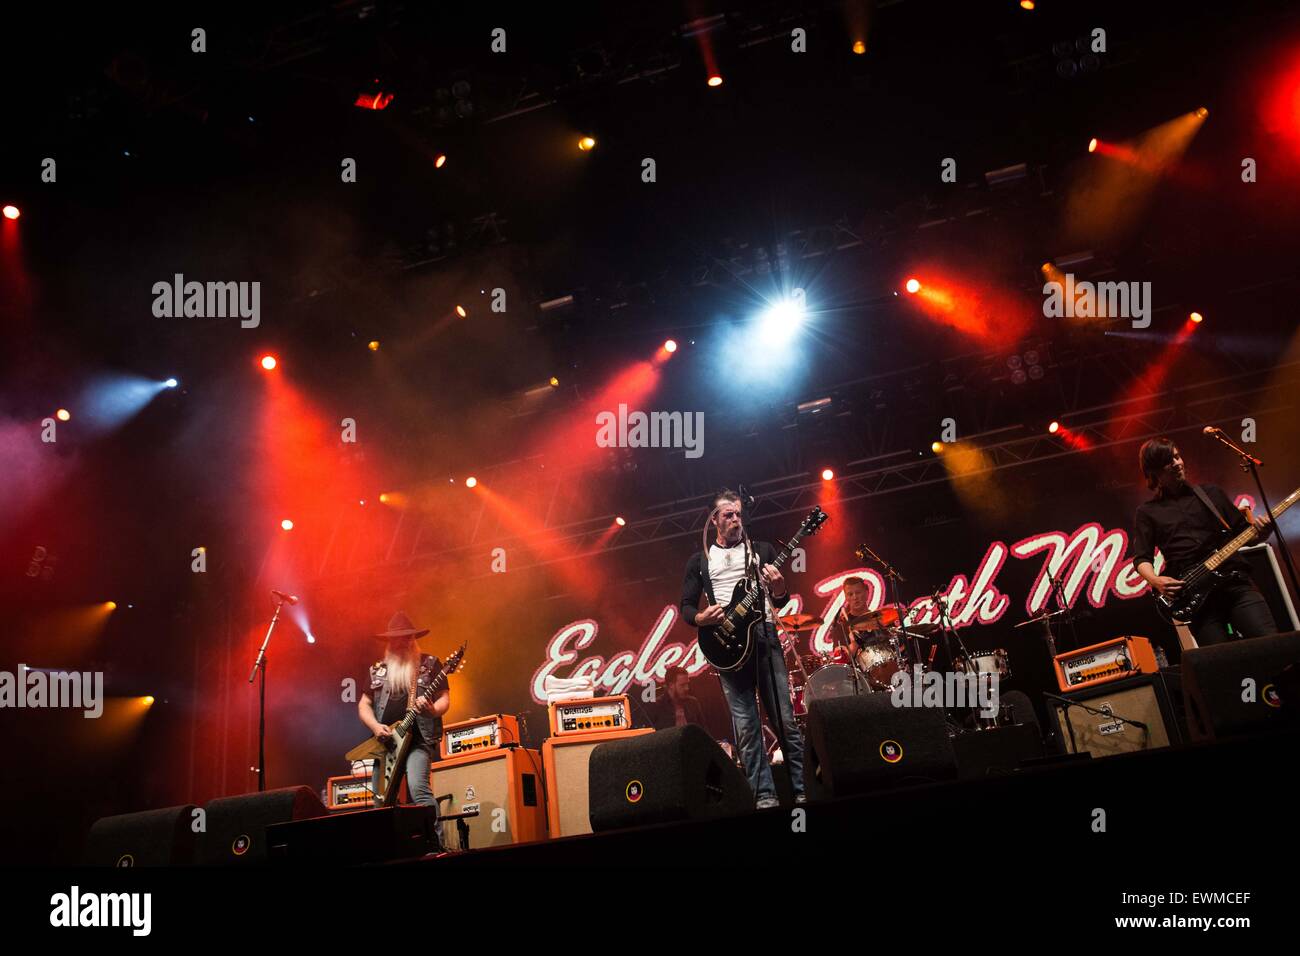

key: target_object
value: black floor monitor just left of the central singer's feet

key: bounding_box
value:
[589,723,754,834]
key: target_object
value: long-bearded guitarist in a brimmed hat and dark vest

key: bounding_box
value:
[356,611,451,806]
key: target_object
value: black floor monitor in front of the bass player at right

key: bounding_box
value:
[1183,631,1300,740]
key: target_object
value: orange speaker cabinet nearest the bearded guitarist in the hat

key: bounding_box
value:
[429,747,546,849]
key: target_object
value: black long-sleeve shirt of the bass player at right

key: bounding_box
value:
[1132,483,1251,578]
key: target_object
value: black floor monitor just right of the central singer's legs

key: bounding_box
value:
[803,693,957,800]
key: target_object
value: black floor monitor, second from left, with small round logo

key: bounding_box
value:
[198,787,329,866]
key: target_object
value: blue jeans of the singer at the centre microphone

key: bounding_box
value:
[719,622,803,800]
